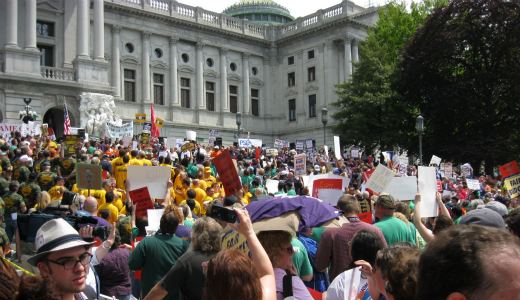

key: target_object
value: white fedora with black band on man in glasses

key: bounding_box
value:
[27,218,94,266]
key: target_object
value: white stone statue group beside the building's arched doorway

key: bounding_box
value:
[79,93,123,138]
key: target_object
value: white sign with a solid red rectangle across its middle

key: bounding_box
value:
[309,174,348,206]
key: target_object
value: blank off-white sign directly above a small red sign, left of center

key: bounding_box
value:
[127,166,171,199]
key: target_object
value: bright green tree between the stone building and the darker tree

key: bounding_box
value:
[333,0,446,149]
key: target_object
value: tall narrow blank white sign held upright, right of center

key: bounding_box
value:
[417,166,439,218]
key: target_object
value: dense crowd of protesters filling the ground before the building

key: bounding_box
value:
[0,132,520,300]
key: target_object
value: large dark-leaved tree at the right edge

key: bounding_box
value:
[397,0,520,168]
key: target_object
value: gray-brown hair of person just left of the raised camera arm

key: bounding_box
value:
[191,217,222,253]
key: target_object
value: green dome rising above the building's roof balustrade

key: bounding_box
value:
[223,0,294,24]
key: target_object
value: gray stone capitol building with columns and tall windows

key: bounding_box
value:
[0,0,378,146]
